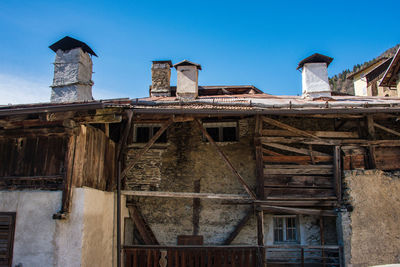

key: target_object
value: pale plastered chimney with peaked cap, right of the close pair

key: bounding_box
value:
[174,60,201,100]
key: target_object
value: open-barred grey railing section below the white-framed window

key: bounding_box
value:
[265,246,343,267]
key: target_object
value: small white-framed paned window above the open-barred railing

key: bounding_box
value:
[274,216,298,243]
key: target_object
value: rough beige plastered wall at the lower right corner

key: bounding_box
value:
[340,170,400,266]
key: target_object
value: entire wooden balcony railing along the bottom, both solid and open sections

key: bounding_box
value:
[124,245,343,267]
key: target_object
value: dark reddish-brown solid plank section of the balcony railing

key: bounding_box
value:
[124,246,258,267]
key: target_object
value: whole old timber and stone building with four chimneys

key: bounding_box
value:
[0,38,400,267]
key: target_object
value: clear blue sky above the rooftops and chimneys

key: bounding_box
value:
[0,0,400,104]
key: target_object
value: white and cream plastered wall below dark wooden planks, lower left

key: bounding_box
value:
[0,188,122,267]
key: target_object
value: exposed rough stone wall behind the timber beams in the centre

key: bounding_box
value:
[125,118,336,248]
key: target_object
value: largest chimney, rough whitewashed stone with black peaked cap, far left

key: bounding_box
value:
[49,36,97,102]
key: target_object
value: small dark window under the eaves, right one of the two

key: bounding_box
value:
[203,122,239,142]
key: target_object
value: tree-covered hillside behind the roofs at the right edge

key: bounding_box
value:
[329,44,400,95]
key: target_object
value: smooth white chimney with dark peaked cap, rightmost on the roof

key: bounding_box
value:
[297,53,333,99]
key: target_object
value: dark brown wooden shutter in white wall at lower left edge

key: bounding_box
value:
[0,215,15,267]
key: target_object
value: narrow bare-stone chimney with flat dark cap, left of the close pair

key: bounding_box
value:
[150,60,172,96]
